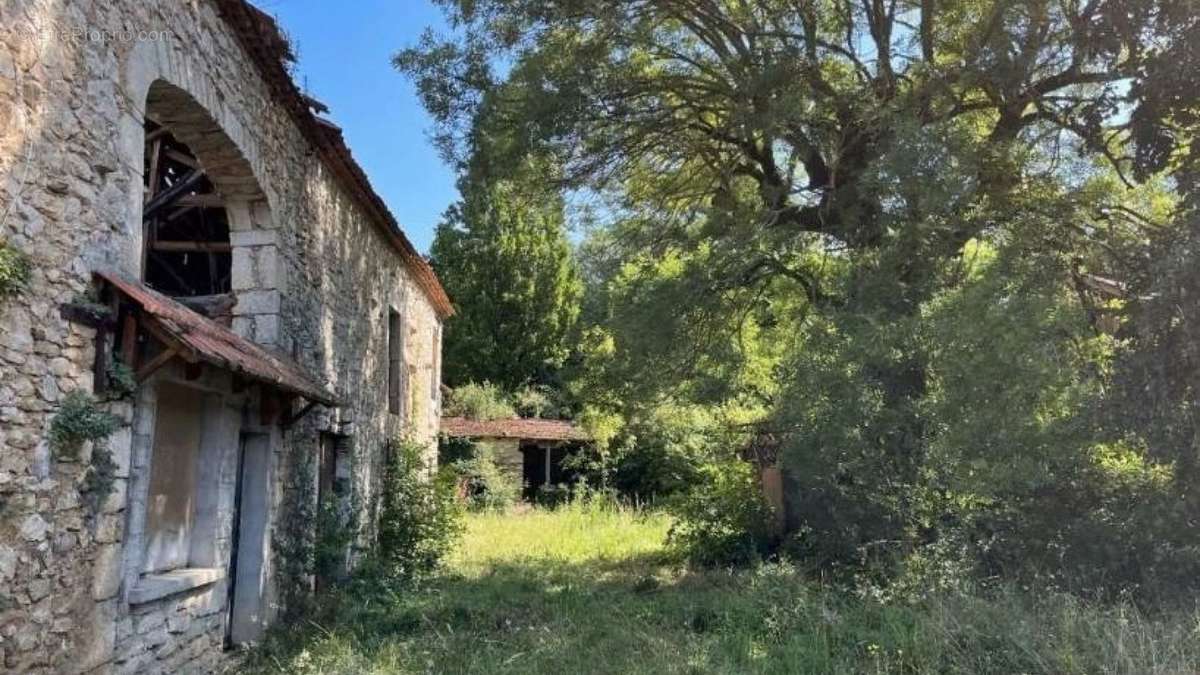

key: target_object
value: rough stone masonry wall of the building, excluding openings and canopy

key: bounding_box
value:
[0,0,440,671]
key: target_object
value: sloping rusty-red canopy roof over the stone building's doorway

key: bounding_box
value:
[95,270,338,406]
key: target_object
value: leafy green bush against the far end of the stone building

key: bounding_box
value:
[374,438,463,581]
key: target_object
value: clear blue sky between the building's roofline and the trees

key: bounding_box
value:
[253,0,457,252]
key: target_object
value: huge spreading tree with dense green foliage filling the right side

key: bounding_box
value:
[397,0,1200,596]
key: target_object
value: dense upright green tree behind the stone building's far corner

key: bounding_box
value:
[432,163,581,390]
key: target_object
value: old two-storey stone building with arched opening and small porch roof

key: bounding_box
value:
[0,0,451,673]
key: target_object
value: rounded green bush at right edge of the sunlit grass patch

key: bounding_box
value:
[667,460,773,566]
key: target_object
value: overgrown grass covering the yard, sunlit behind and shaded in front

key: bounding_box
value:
[245,503,1200,674]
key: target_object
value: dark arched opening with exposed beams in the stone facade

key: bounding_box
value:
[142,119,233,298]
